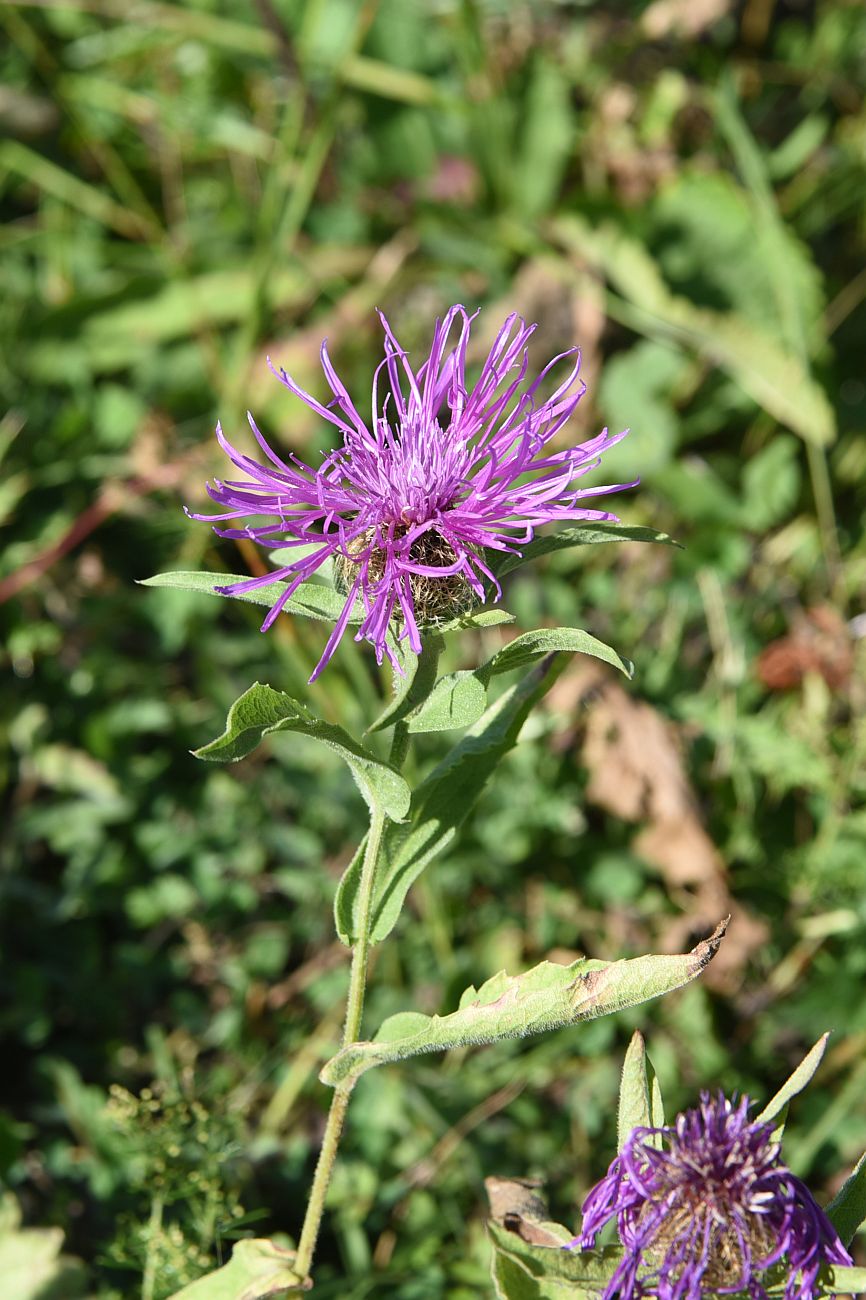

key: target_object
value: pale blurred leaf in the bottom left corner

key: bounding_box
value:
[0,1195,87,1300]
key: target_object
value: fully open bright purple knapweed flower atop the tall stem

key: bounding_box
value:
[192,307,635,681]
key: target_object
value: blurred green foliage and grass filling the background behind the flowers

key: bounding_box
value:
[0,0,866,1300]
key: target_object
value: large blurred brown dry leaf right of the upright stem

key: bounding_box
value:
[554,664,767,991]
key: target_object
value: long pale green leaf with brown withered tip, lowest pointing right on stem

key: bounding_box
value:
[321,920,727,1087]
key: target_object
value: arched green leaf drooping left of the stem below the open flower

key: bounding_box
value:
[194,681,411,822]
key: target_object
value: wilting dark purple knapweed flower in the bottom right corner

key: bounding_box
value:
[570,1092,852,1300]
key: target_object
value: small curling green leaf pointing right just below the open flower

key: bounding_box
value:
[407,628,633,732]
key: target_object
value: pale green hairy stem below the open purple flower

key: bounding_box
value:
[294,810,385,1278]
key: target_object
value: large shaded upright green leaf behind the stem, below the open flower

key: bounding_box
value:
[334,655,566,944]
